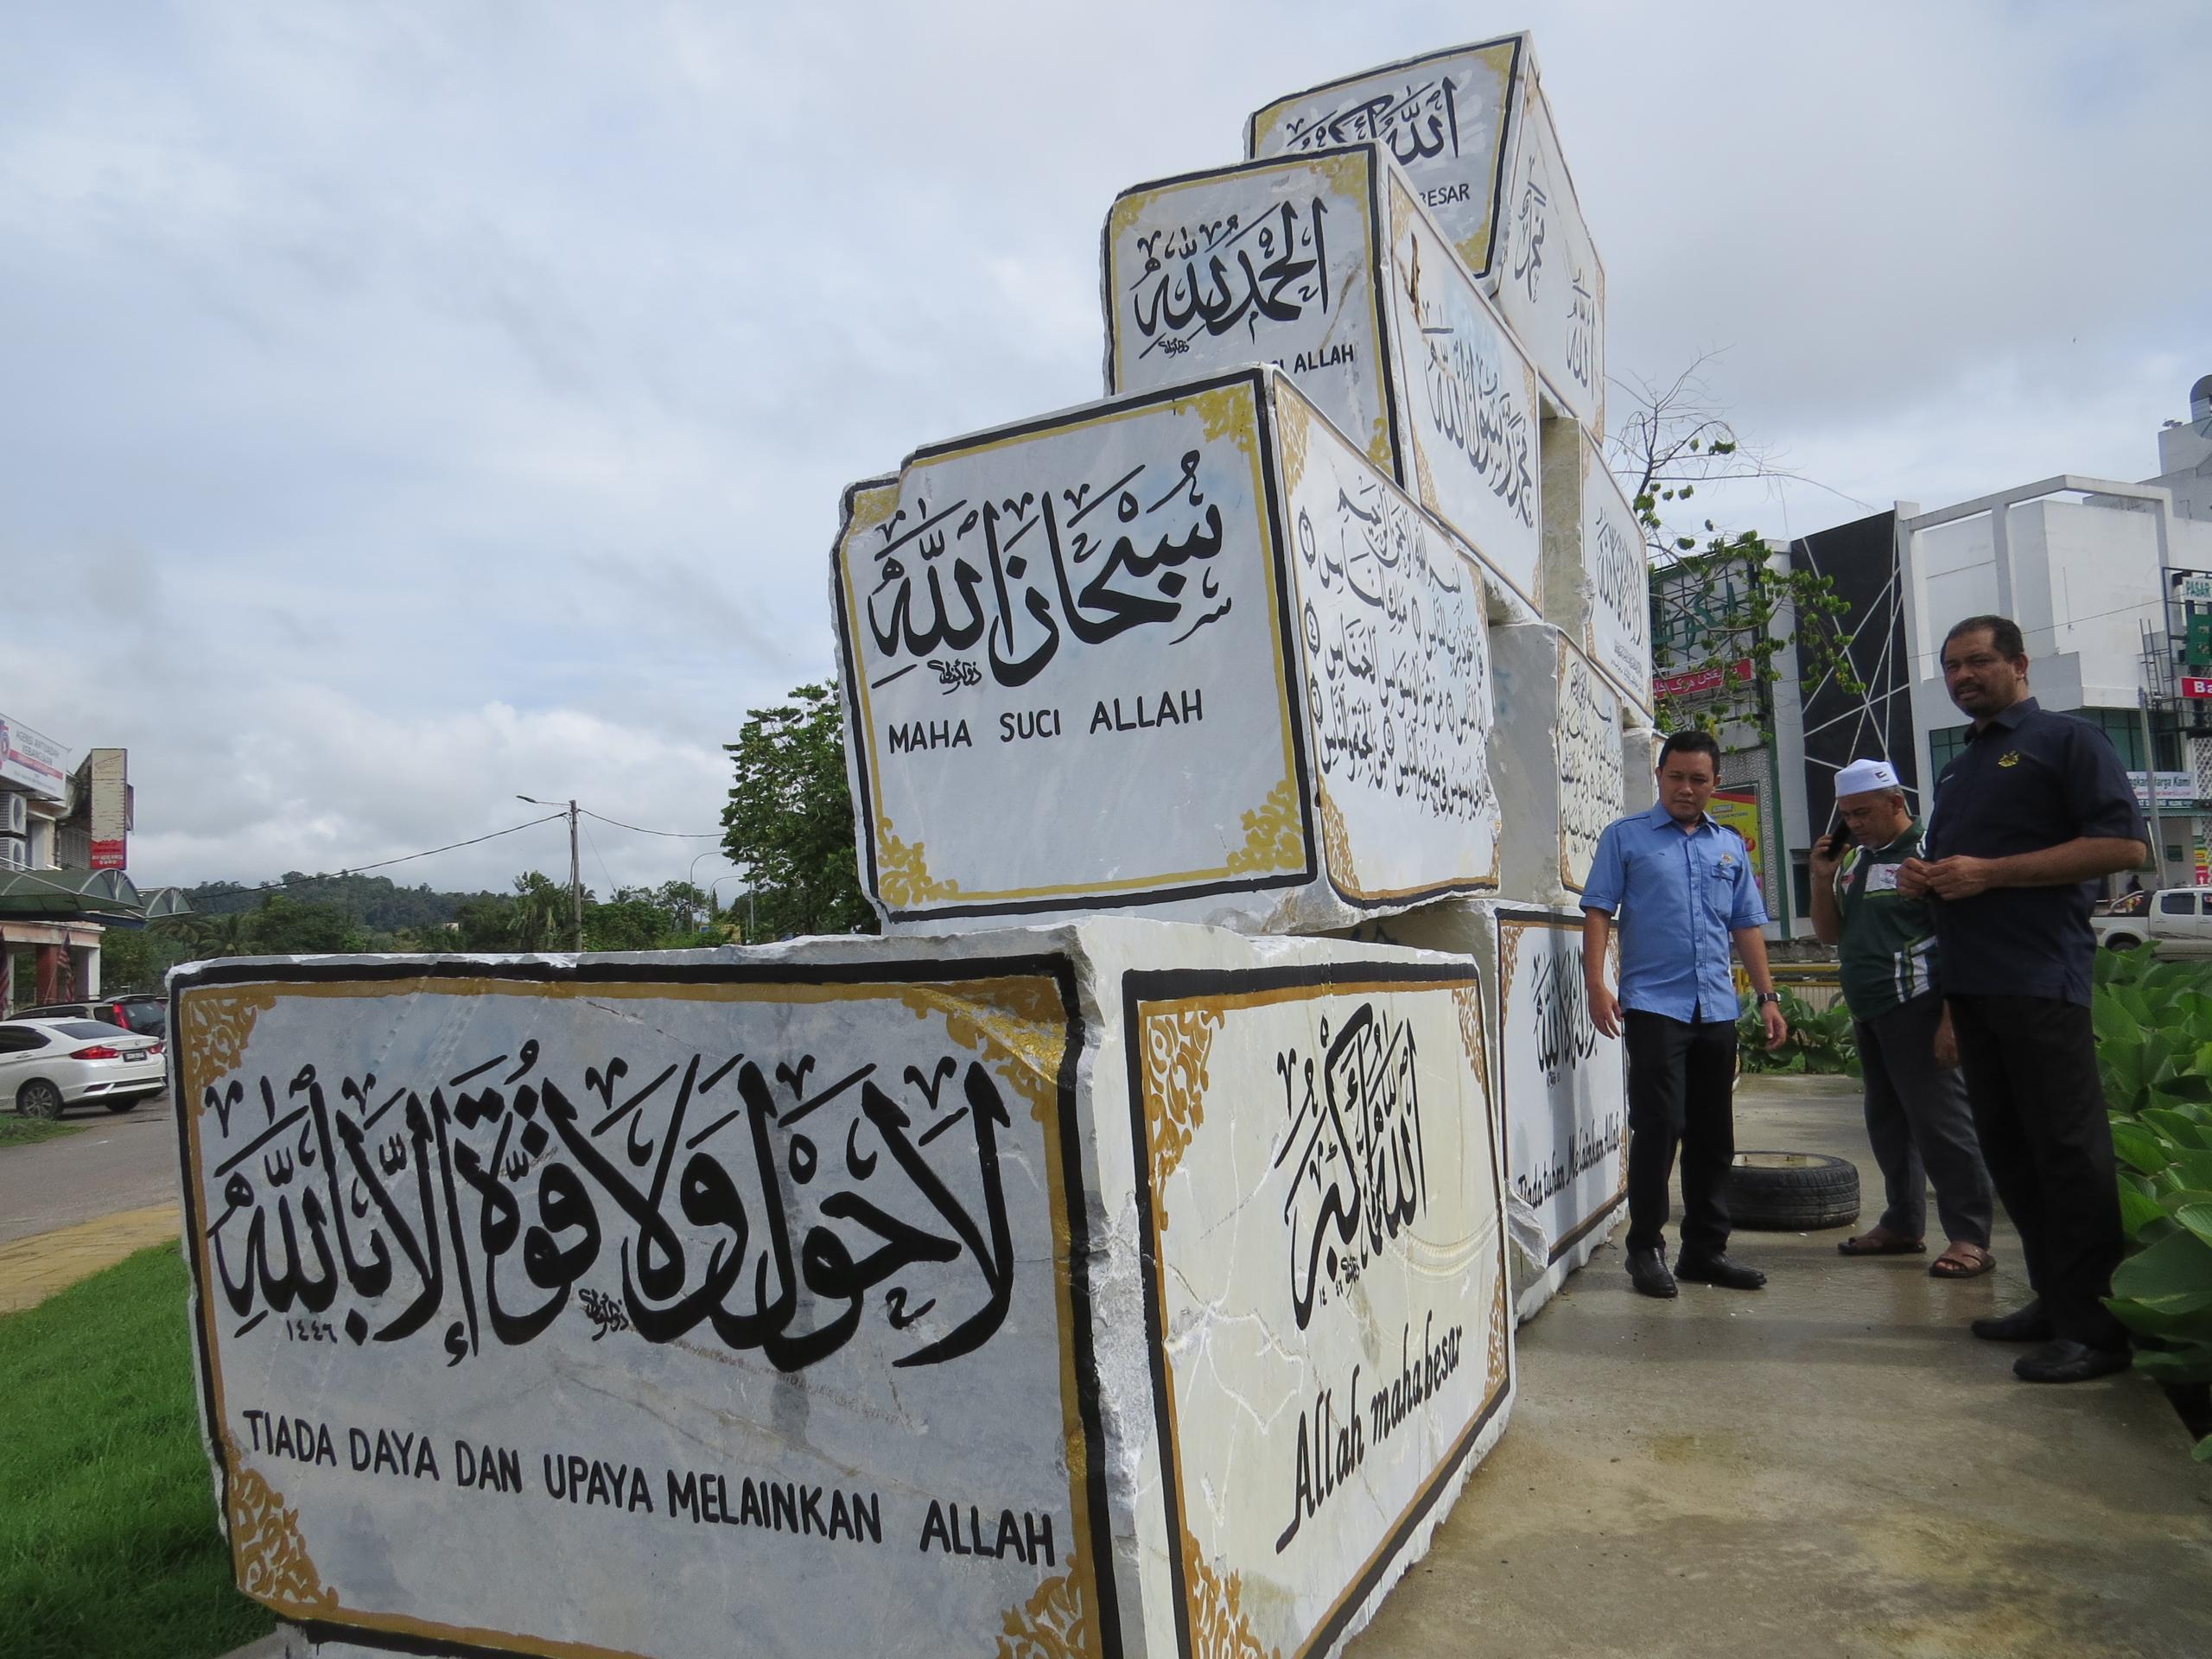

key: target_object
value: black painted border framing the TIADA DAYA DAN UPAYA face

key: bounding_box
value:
[168,956,1123,1659]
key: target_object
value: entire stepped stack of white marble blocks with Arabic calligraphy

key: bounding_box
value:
[173,35,1650,1659]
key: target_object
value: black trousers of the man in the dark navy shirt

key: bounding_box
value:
[1947,995,2128,1347]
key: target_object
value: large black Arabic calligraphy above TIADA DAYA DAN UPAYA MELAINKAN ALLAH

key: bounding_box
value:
[204,1039,1015,1371]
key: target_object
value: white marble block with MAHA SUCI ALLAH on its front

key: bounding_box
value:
[832,370,1500,931]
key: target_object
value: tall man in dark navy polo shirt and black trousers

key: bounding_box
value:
[1897,617,2150,1382]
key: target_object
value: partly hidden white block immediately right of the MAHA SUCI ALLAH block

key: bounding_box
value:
[1491,621,1626,907]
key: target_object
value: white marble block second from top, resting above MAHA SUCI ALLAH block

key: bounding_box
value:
[1102,143,1541,620]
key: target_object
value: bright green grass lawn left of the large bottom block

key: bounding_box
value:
[0,1245,274,1659]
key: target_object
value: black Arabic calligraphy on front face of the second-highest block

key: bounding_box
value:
[1123,197,1330,359]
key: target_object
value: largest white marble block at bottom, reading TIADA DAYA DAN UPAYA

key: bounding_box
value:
[170,920,1513,1659]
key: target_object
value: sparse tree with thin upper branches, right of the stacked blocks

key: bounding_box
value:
[1606,356,1865,743]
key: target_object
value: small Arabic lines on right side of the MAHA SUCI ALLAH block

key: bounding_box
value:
[1299,478,1496,823]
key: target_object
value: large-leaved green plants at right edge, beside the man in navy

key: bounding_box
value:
[2090,949,2212,1462]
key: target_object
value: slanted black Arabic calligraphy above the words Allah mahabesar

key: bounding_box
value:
[1274,1002,1429,1330]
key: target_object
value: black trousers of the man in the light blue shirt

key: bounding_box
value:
[1621,1008,1737,1256]
